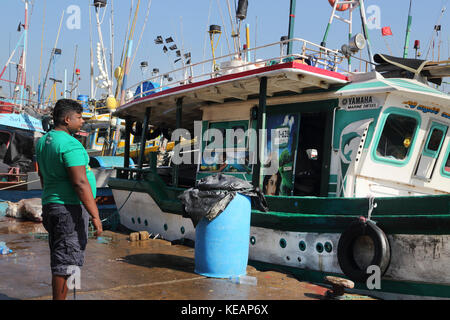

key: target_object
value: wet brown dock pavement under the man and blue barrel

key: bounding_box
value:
[0,217,376,300]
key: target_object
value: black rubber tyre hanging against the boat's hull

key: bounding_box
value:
[337,218,391,283]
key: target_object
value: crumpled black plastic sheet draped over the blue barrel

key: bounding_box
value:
[179,173,268,227]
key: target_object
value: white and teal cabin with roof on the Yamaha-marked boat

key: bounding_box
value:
[110,40,450,197]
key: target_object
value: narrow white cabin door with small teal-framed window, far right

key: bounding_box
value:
[415,122,448,179]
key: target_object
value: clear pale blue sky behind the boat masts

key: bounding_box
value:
[0,0,450,98]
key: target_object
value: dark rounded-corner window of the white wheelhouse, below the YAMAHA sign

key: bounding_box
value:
[376,113,418,161]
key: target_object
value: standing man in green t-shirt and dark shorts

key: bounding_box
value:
[36,99,103,300]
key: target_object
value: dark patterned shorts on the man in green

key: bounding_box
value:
[42,203,89,276]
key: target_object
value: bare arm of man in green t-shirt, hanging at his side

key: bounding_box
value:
[67,166,103,237]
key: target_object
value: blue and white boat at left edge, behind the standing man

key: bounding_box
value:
[0,1,46,192]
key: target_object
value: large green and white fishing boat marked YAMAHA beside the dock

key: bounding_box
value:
[108,0,450,299]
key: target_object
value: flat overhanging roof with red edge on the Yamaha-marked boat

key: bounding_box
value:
[113,61,349,123]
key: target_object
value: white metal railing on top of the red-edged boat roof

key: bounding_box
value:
[121,38,370,103]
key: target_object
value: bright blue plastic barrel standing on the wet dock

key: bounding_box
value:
[195,193,251,278]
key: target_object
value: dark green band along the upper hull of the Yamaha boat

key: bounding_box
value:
[109,175,450,235]
